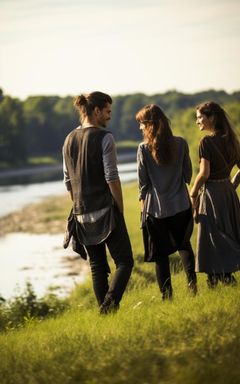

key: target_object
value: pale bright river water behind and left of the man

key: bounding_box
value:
[0,163,137,299]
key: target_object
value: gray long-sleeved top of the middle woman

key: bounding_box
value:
[137,136,192,218]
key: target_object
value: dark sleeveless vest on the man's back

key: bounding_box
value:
[63,127,112,214]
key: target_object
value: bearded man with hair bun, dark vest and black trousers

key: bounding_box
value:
[63,92,133,314]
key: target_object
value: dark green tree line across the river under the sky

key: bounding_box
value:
[0,89,240,168]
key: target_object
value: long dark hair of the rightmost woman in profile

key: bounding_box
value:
[196,101,240,164]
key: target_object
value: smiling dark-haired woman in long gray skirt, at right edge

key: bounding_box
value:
[190,102,240,287]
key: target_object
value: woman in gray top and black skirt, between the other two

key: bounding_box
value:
[136,104,197,299]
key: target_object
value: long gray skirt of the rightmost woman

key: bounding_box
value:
[196,179,240,273]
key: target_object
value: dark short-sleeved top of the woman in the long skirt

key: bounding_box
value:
[199,135,240,180]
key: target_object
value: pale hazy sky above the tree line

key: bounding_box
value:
[0,0,240,98]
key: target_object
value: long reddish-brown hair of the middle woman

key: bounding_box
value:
[136,104,175,165]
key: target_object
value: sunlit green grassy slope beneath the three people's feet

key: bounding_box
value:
[0,184,240,384]
